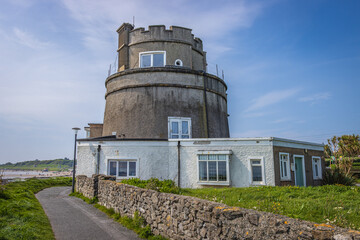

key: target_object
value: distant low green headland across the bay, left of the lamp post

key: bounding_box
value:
[0,159,73,171]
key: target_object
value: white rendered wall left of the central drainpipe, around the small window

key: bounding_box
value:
[76,141,173,179]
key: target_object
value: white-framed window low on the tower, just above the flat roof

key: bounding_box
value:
[168,117,191,138]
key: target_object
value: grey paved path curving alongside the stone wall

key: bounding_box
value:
[36,187,139,240]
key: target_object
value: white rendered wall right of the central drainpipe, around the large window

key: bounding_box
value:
[169,139,275,188]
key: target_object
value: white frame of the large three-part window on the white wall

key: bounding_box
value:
[197,151,232,186]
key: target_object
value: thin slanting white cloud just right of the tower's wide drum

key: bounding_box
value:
[245,88,300,112]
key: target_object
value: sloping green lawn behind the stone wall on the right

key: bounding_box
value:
[180,185,360,230]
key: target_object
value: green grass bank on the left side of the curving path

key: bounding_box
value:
[0,177,71,240]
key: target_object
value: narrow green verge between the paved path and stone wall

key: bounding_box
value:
[70,192,167,240]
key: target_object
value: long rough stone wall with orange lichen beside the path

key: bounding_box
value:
[76,175,360,240]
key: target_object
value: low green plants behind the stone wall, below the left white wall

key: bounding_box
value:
[121,178,180,194]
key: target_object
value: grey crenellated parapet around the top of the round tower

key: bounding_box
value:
[129,25,203,52]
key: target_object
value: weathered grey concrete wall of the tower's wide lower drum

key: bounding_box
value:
[103,68,229,139]
